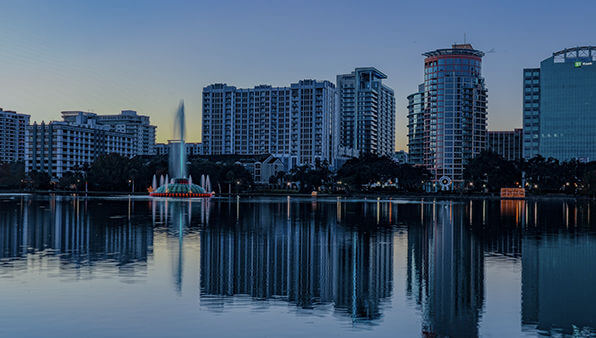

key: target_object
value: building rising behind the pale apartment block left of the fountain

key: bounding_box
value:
[62,110,156,155]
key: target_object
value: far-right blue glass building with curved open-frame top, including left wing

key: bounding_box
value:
[523,46,596,161]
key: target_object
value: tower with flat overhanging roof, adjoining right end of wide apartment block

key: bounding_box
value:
[337,67,395,156]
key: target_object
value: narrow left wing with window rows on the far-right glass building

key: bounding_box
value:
[522,68,540,159]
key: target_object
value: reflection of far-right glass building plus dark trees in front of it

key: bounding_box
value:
[522,201,596,336]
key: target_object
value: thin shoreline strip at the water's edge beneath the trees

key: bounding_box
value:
[0,190,596,201]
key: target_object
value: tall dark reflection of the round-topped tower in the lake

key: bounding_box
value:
[407,202,484,337]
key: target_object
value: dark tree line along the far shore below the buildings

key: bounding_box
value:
[0,151,596,195]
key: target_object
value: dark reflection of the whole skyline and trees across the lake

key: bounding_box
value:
[0,196,596,336]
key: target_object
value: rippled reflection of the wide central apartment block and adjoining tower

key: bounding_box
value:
[201,201,393,321]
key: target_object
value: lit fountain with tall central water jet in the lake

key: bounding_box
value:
[150,102,211,197]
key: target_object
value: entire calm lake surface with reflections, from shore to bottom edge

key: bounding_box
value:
[0,196,596,337]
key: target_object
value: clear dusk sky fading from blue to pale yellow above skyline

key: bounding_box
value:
[0,0,596,150]
